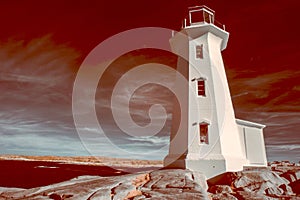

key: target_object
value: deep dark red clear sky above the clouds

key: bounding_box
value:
[0,0,299,71]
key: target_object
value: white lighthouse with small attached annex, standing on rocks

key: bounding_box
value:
[164,6,267,178]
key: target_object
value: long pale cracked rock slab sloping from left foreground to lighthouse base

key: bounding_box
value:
[0,169,208,200]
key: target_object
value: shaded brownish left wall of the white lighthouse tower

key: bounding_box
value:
[164,34,189,164]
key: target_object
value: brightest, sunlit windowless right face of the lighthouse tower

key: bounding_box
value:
[208,33,247,171]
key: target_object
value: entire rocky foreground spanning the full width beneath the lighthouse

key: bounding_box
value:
[0,161,300,200]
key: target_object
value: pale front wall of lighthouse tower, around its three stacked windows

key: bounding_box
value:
[188,33,223,159]
